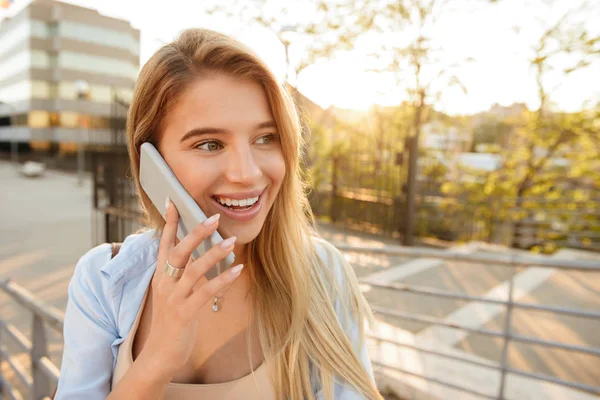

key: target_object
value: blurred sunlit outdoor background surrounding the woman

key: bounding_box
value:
[0,0,600,399]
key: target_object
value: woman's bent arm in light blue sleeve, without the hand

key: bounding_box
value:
[54,246,170,400]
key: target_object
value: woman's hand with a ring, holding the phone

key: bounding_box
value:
[139,199,243,382]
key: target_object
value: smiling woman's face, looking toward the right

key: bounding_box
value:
[159,74,285,246]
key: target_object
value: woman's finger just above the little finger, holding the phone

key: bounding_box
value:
[174,236,237,298]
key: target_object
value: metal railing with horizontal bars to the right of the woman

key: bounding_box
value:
[336,244,600,400]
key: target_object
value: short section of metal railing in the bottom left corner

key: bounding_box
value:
[0,280,64,400]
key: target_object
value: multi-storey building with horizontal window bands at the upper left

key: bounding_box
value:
[0,0,140,156]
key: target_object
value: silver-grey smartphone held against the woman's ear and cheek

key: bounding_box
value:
[140,142,234,280]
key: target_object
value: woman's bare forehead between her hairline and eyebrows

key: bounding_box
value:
[163,75,273,139]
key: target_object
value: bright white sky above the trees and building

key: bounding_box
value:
[0,0,600,114]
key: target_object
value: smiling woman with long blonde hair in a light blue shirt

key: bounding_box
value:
[56,29,381,400]
